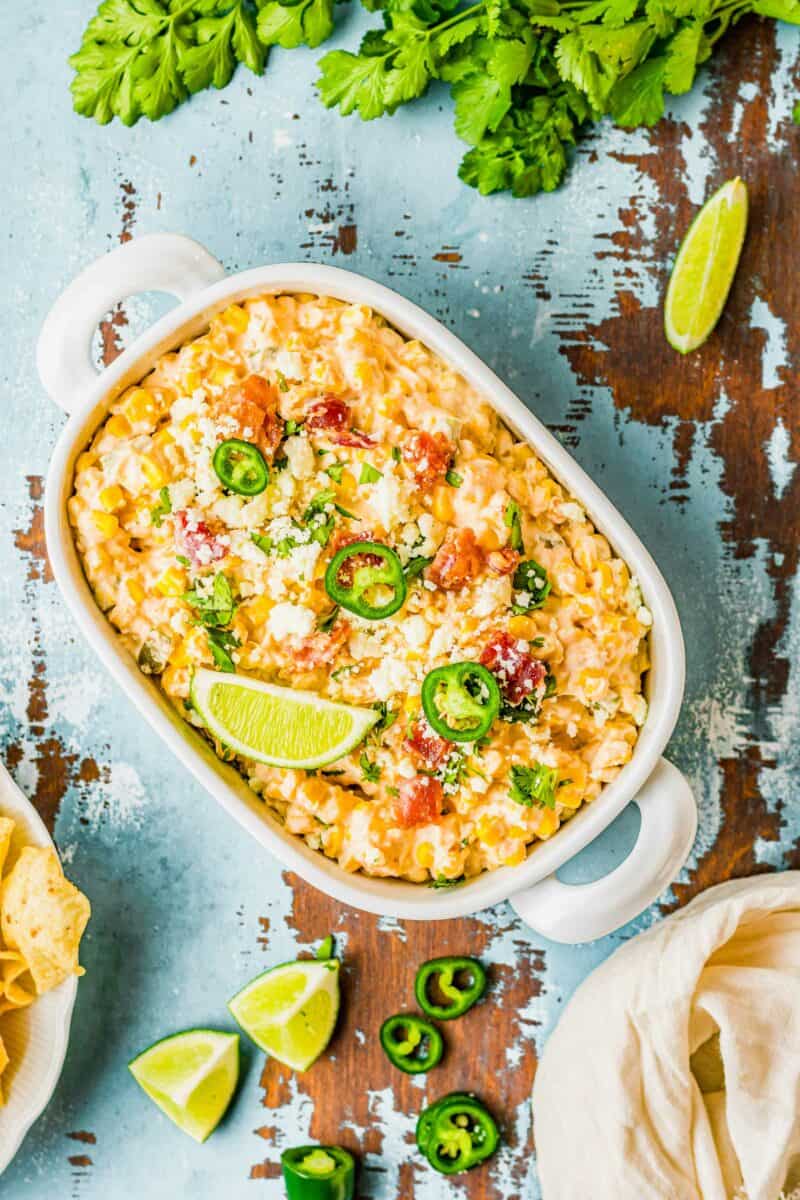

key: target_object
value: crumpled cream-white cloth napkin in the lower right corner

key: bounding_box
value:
[534,871,800,1200]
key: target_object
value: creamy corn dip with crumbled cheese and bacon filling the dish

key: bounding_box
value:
[68,295,651,882]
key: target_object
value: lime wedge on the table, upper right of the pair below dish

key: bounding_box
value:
[228,959,339,1070]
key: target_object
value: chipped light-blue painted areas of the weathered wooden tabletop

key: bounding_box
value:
[0,0,800,1200]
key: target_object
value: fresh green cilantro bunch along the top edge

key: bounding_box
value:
[70,0,800,196]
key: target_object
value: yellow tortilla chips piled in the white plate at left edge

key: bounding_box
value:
[0,817,91,1104]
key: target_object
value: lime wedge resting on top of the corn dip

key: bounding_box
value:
[192,668,379,769]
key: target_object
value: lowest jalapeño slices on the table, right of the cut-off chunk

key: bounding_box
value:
[416,1092,500,1175]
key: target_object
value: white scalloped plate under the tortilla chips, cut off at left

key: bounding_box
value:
[0,764,78,1174]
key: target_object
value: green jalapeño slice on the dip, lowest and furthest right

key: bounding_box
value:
[422,662,501,742]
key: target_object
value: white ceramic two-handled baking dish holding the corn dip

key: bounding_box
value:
[37,234,697,941]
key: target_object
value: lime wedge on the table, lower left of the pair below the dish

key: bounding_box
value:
[128,1030,239,1141]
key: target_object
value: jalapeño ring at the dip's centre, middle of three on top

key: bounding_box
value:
[325,541,407,620]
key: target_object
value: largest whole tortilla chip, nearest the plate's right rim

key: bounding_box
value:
[0,846,91,996]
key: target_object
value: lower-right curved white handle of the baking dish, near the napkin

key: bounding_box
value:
[511,758,697,943]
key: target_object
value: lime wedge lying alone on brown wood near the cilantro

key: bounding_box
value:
[664,178,747,354]
